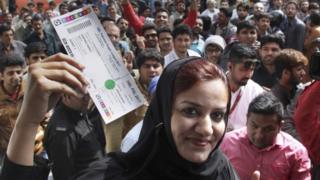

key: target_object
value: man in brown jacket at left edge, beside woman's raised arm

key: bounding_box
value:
[0,54,24,167]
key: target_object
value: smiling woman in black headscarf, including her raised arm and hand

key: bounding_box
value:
[2,54,238,180]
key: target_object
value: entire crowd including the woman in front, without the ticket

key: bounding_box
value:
[0,0,320,180]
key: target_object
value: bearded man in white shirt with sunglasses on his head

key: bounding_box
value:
[227,43,264,131]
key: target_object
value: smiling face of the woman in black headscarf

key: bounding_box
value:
[171,79,228,163]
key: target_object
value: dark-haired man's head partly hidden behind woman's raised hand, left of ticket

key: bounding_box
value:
[25,42,48,65]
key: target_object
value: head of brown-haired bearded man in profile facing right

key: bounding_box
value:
[274,49,308,86]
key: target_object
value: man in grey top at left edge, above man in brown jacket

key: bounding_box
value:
[0,25,26,58]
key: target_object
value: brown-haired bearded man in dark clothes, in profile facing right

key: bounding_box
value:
[271,49,308,139]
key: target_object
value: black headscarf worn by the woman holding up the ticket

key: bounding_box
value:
[74,57,238,180]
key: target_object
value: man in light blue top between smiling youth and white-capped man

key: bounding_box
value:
[190,17,204,54]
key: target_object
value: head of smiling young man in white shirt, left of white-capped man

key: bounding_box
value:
[172,25,192,54]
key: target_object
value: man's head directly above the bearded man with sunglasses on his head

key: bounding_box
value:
[237,21,258,46]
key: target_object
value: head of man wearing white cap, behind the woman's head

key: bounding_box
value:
[204,35,226,64]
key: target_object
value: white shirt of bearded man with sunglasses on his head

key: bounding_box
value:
[228,79,264,129]
